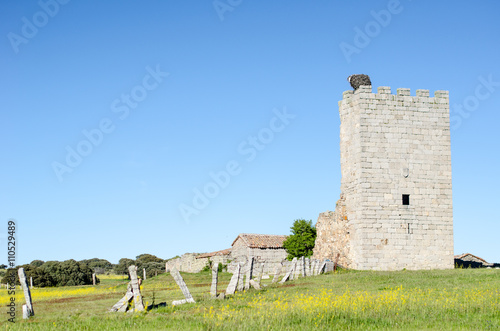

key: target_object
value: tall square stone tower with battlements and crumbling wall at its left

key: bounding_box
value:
[314,86,454,270]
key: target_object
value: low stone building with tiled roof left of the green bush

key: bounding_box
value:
[228,233,288,273]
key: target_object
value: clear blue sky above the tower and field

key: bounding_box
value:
[0,0,500,264]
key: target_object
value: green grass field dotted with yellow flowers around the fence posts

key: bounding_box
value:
[0,269,500,330]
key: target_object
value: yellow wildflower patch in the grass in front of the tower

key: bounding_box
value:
[204,286,500,326]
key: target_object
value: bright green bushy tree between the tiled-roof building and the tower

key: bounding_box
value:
[283,219,316,260]
